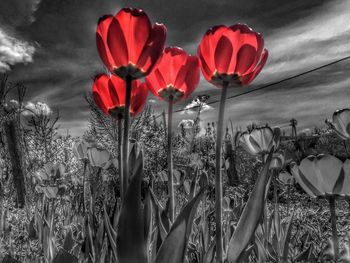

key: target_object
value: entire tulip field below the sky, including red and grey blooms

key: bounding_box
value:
[0,5,350,263]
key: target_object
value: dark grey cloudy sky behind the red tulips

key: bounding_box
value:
[0,0,350,135]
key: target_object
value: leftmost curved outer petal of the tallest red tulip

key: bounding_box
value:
[96,15,115,69]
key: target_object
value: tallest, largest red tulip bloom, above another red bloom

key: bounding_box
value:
[96,8,166,79]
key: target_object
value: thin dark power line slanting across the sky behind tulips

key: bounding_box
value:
[171,56,350,114]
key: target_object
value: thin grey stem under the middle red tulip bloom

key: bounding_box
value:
[167,95,175,223]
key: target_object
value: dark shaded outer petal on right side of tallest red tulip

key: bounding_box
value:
[137,23,166,75]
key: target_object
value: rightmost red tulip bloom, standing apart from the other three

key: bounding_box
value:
[198,24,268,86]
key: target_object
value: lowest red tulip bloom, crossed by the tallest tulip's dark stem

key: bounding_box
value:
[92,74,148,119]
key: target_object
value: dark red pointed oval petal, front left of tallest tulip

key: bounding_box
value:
[107,18,129,67]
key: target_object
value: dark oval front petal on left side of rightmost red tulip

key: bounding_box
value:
[215,36,233,74]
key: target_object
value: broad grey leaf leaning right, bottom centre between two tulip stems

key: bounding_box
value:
[155,191,204,263]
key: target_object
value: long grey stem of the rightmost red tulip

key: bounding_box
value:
[215,82,228,262]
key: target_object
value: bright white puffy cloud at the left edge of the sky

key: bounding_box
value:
[0,28,35,72]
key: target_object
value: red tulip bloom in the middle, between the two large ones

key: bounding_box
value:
[146,47,200,102]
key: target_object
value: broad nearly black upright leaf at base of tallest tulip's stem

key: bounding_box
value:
[117,152,147,263]
